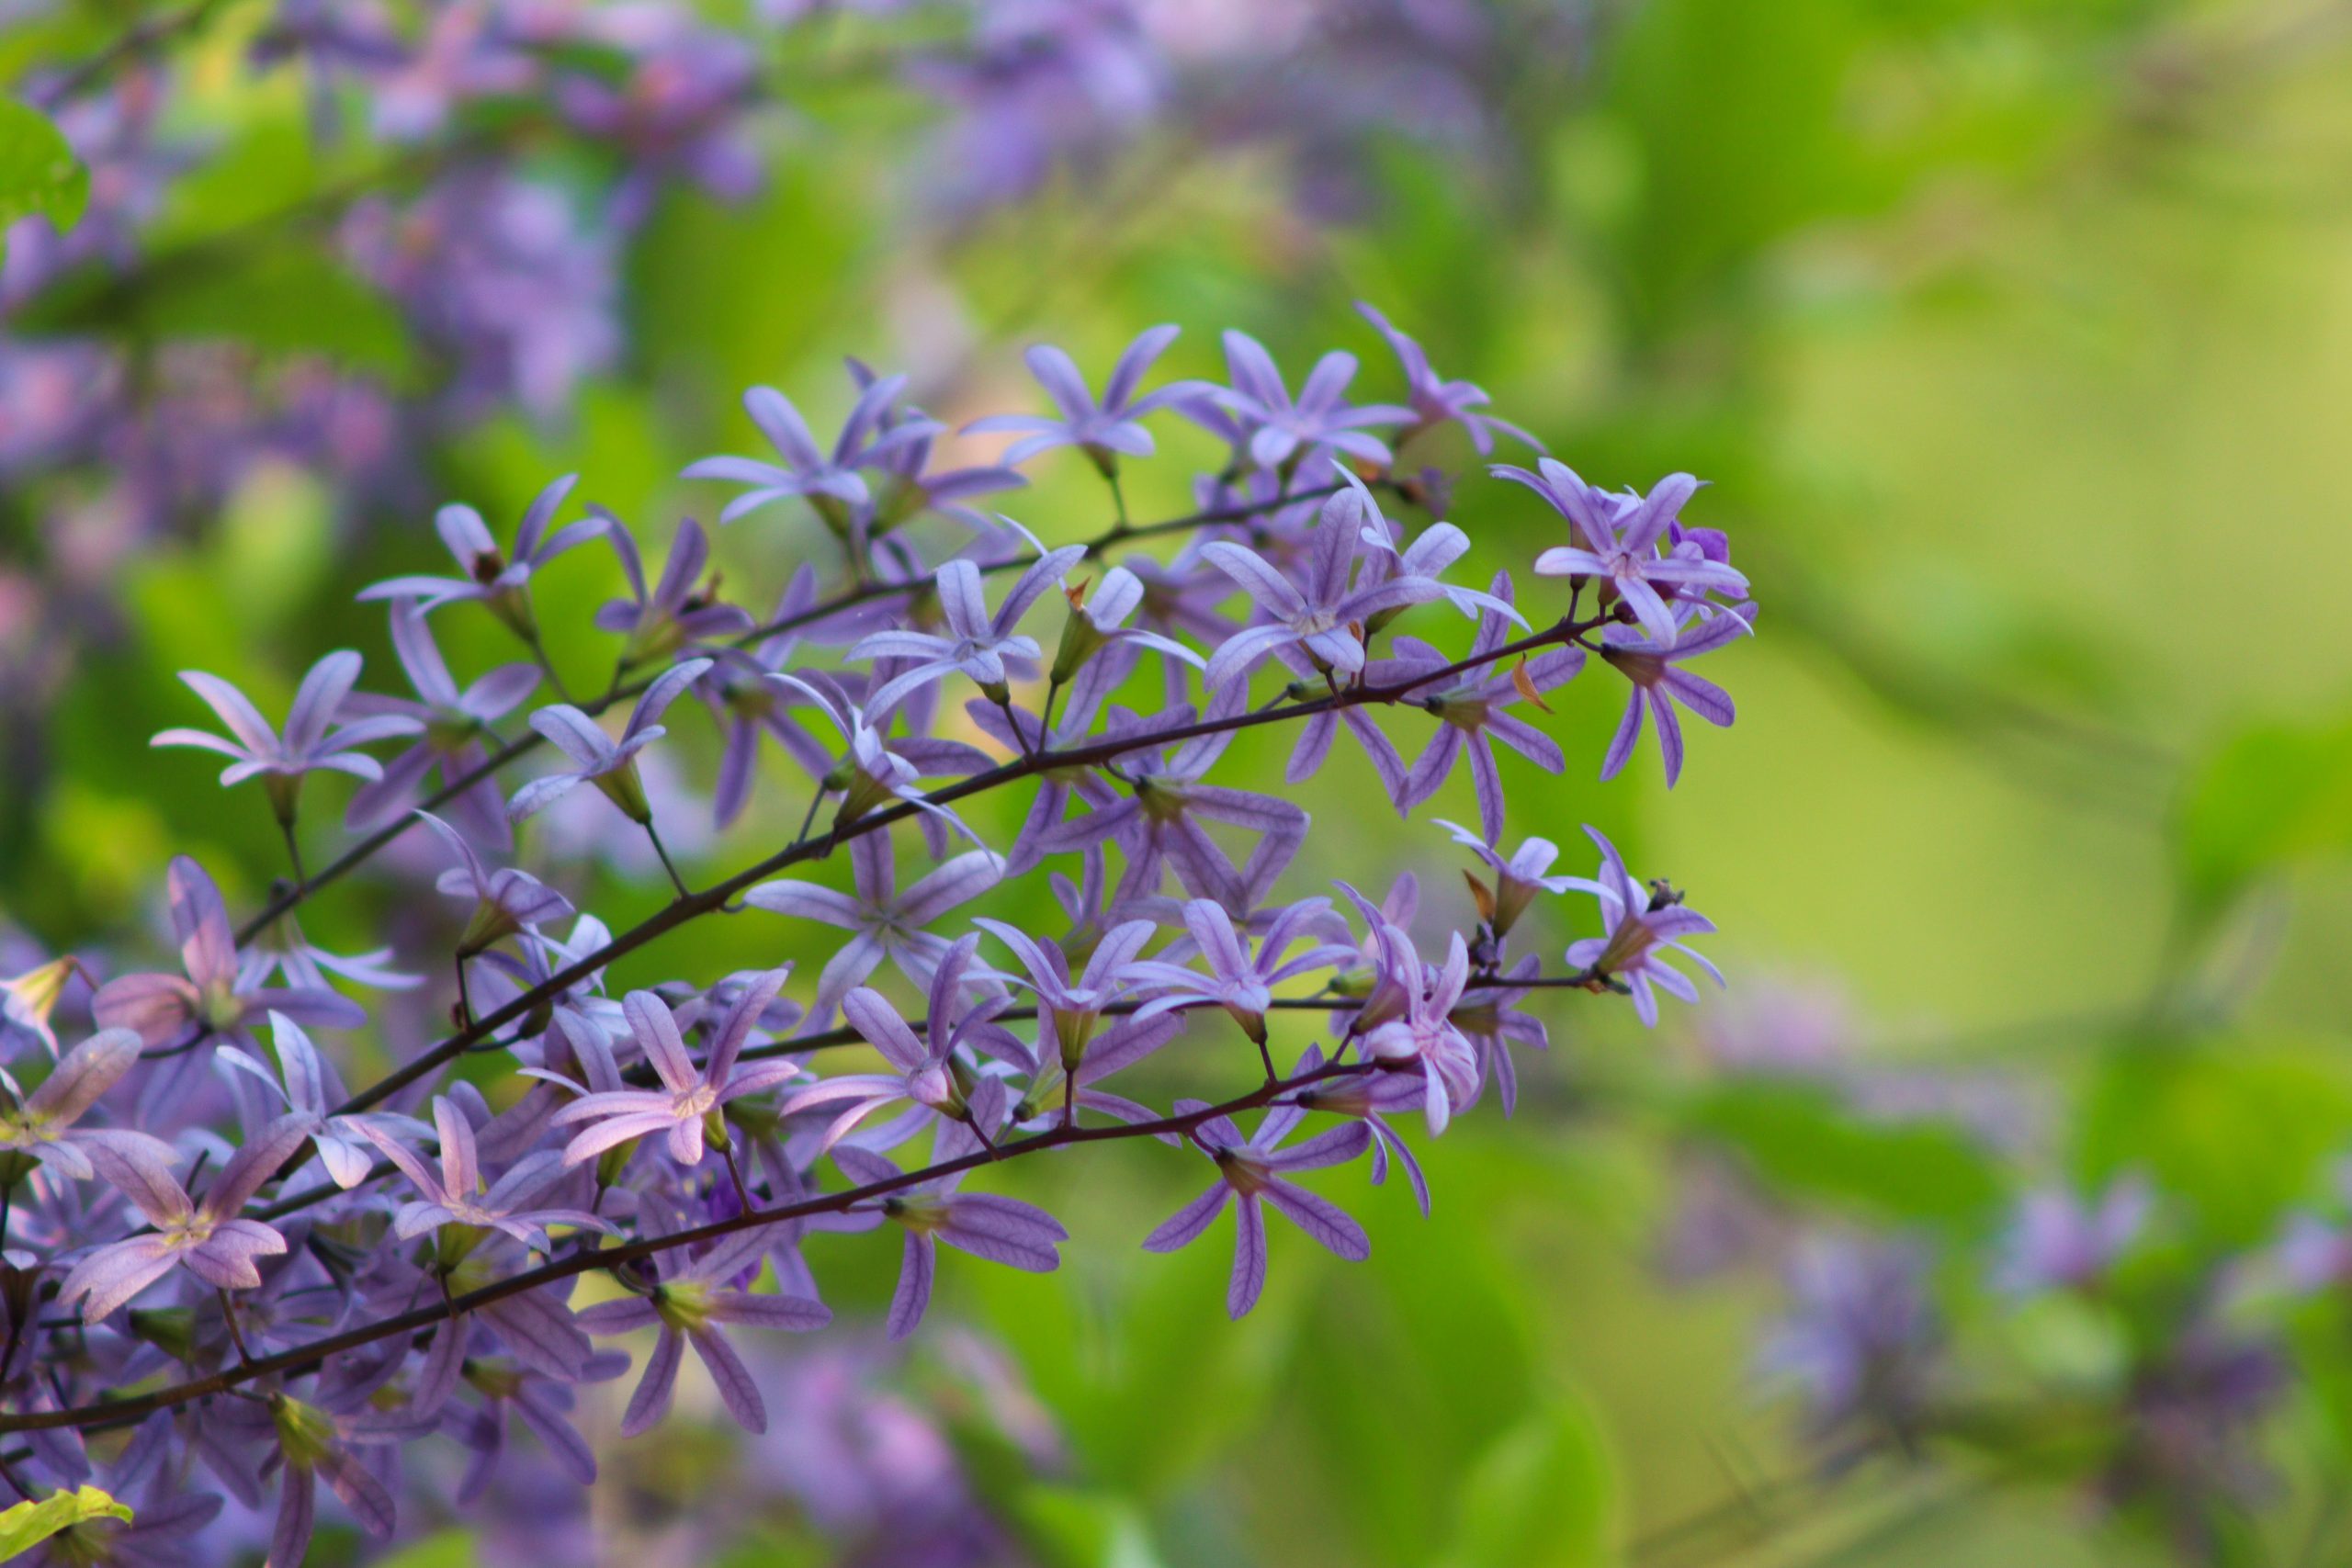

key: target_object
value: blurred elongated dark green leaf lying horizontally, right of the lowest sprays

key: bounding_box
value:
[1687,1081,2004,1223]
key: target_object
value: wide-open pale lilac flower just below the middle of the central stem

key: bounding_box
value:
[743,832,1004,1027]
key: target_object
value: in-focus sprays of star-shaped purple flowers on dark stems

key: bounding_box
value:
[0,310,1752,1561]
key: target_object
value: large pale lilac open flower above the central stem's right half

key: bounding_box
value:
[1200,489,1444,691]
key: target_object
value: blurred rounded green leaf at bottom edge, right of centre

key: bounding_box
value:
[1437,1399,1618,1568]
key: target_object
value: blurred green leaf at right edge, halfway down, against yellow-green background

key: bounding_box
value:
[2173,724,2352,912]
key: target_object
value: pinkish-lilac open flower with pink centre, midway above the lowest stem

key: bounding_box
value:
[553,964,802,1166]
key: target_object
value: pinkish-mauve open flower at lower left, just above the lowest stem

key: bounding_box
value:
[56,1117,311,1324]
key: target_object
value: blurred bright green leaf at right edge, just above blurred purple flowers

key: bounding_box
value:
[2076,1039,2352,1248]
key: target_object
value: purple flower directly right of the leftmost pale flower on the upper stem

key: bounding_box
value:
[344,600,538,849]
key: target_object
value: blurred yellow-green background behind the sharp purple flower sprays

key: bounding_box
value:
[14,0,2352,1568]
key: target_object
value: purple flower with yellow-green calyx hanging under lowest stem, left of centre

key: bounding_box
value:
[579,1227,832,1437]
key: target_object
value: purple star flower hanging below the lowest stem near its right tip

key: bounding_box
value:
[1143,1100,1371,1316]
